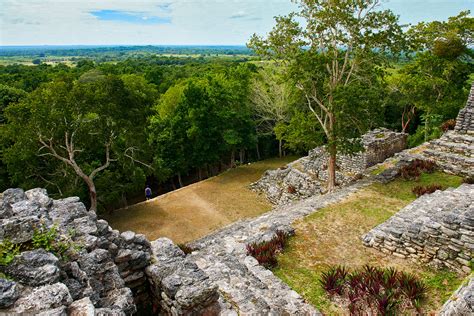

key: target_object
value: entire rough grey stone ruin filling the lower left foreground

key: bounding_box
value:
[0,189,219,316]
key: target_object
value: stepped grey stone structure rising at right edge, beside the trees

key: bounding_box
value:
[423,84,474,177]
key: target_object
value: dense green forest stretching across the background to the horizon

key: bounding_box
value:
[0,7,474,210]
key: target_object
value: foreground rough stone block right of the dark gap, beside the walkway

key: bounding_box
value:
[146,238,221,315]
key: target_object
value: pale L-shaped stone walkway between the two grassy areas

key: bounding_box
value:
[188,180,372,315]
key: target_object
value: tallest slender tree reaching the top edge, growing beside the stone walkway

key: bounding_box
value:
[248,0,403,191]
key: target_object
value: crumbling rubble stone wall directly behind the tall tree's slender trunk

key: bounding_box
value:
[250,129,407,205]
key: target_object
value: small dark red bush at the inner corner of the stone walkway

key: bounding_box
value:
[247,231,289,269]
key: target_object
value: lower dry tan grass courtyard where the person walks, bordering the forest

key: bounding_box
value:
[104,157,298,243]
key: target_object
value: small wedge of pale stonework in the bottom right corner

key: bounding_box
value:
[439,276,474,316]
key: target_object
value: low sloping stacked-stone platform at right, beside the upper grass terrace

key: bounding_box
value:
[362,184,474,273]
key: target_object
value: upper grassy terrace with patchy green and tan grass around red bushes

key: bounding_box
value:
[274,172,463,315]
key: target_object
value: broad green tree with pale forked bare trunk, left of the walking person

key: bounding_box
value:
[5,76,154,211]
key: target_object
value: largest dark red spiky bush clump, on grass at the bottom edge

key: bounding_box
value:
[320,265,427,315]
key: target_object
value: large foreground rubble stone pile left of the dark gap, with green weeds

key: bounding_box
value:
[0,189,141,315]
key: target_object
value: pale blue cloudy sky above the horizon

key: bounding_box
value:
[0,0,474,46]
